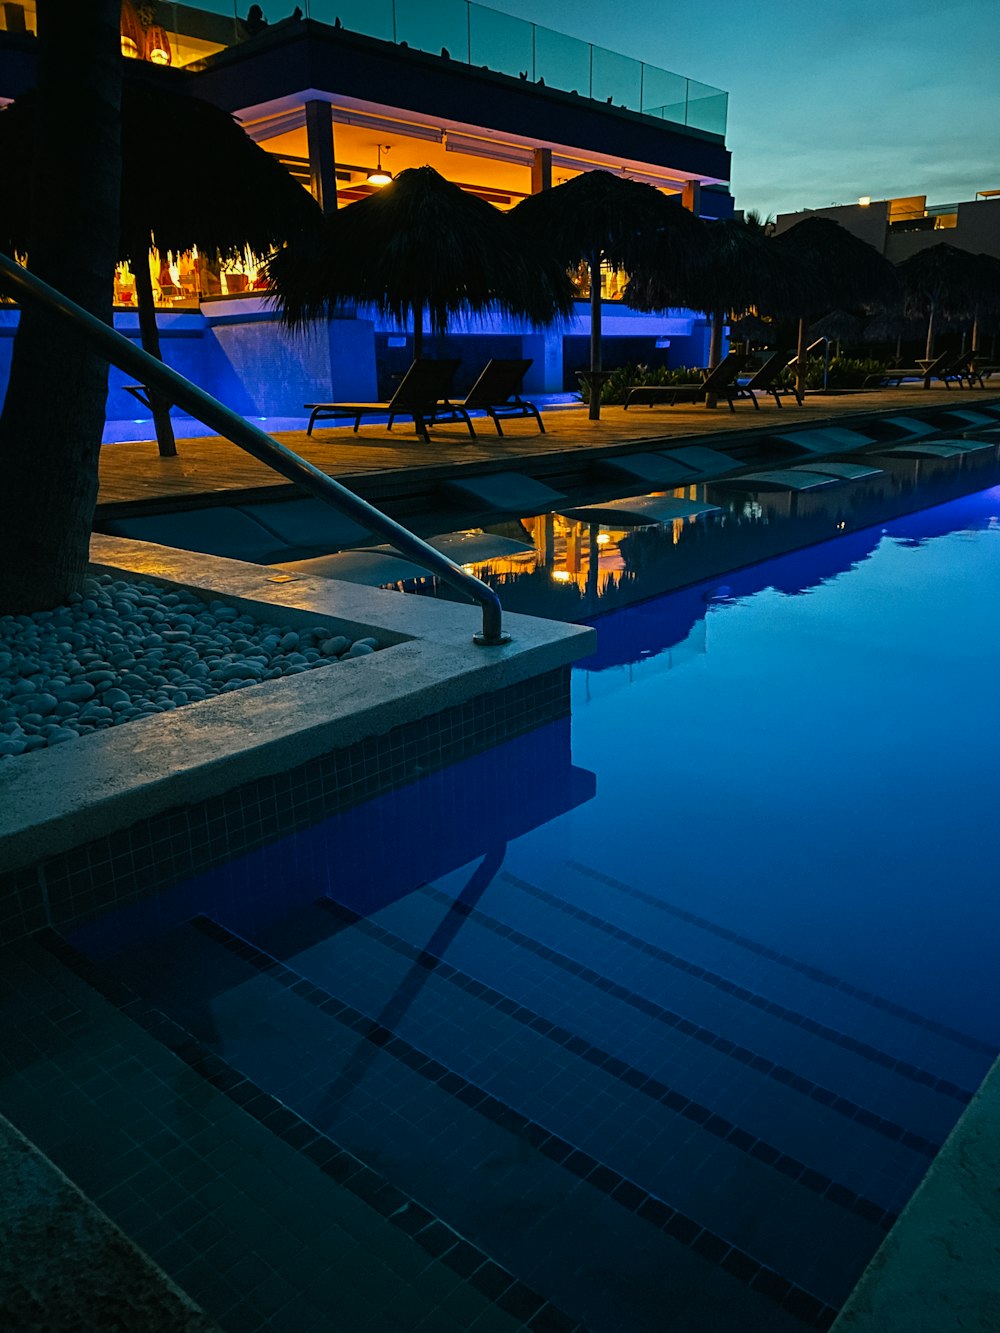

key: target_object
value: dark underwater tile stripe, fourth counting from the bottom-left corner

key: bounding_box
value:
[420,874,940,1158]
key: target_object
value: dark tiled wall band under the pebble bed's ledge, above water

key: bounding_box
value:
[0,667,569,944]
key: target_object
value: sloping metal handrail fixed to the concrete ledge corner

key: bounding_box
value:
[0,253,511,647]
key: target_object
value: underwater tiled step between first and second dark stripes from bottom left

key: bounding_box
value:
[106,922,832,1333]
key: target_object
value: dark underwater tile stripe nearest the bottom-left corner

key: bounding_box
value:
[36,917,588,1333]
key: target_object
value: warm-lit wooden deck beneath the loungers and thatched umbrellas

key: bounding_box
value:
[99,387,999,507]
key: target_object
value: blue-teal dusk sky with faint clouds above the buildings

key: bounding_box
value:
[487,0,1000,215]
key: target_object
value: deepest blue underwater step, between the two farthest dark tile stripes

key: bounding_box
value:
[552,860,996,1090]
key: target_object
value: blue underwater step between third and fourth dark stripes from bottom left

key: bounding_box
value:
[330,889,949,1210]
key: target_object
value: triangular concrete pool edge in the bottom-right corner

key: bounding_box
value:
[833,1061,1000,1333]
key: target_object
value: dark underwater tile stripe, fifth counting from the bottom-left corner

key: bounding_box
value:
[503,873,972,1106]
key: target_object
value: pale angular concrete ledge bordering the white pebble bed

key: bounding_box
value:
[0,537,595,872]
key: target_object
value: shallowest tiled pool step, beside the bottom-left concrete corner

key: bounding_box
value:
[0,942,535,1333]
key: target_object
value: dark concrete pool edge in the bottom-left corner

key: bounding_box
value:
[0,1117,219,1333]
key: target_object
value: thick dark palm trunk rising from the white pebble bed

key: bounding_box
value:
[0,0,121,613]
